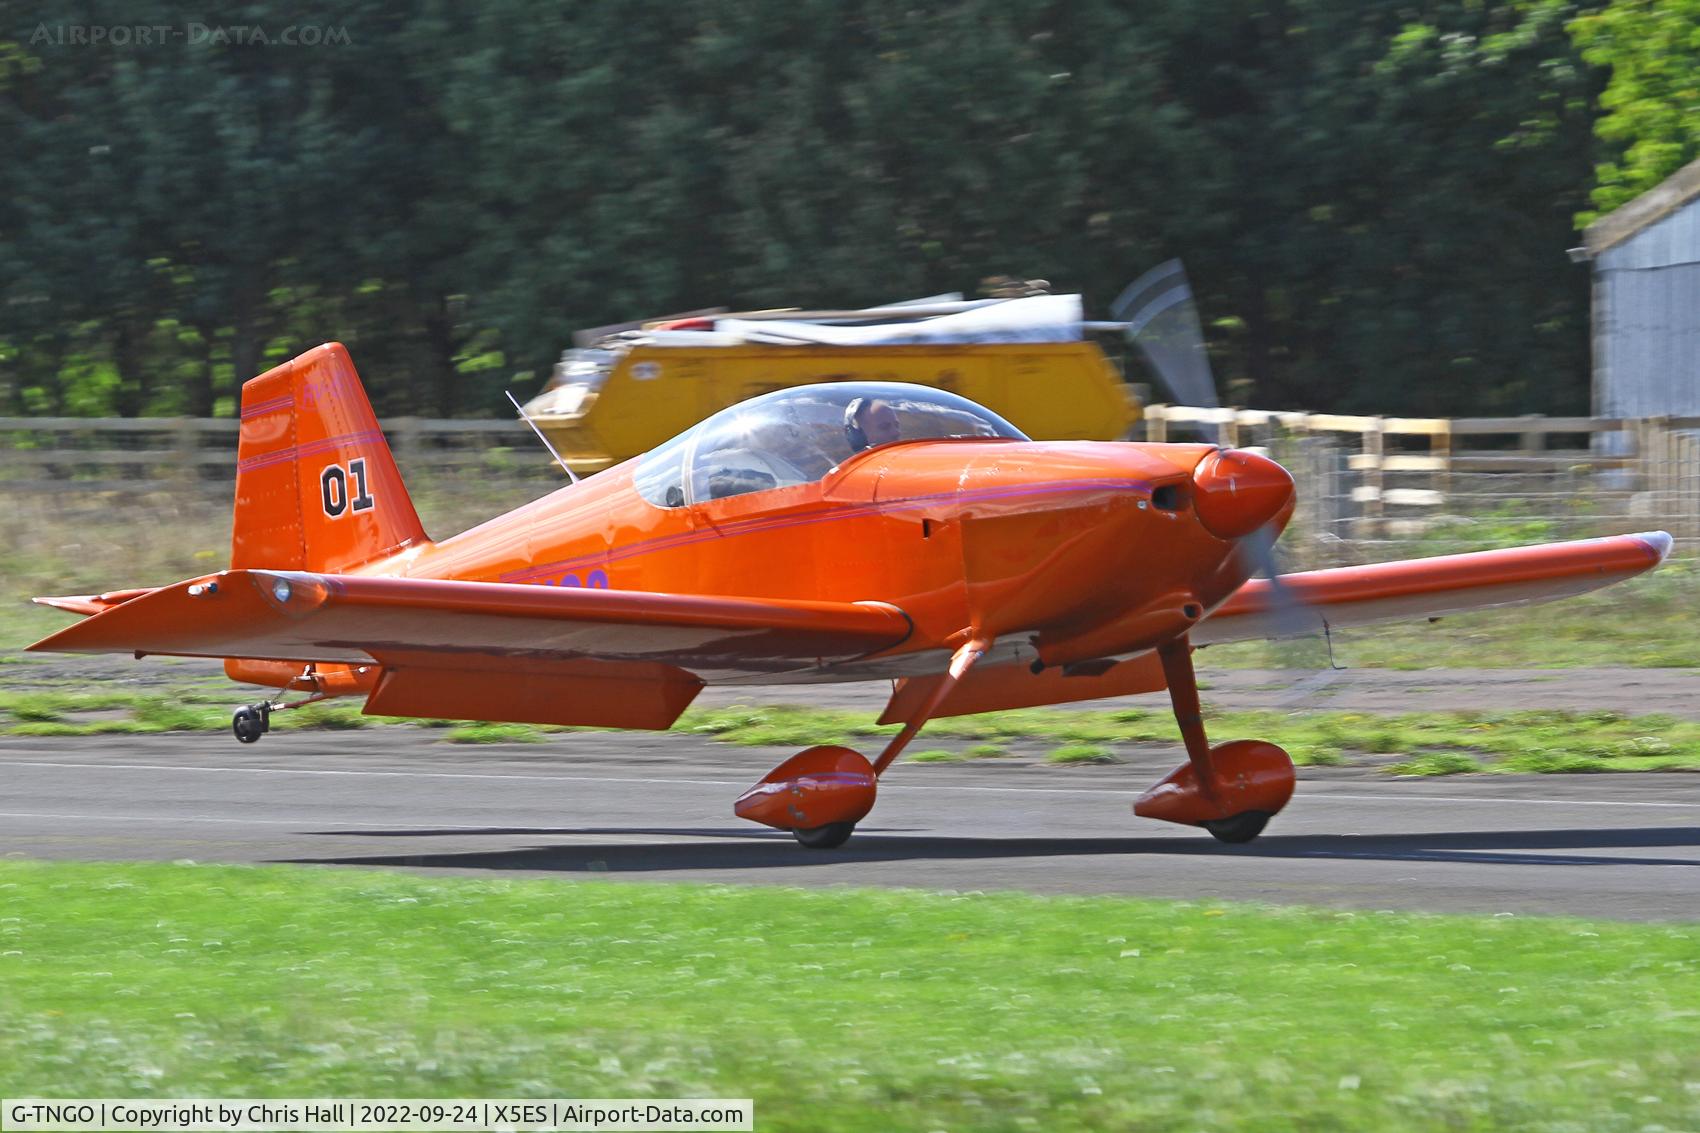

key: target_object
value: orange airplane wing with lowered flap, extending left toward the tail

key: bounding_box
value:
[29,570,911,728]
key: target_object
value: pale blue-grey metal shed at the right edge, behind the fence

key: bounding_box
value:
[1583,162,1700,417]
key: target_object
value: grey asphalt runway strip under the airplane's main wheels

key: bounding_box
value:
[0,726,1700,920]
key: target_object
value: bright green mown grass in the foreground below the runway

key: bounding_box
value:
[0,863,1700,1133]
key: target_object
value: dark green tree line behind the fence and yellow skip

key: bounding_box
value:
[0,0,1652,413]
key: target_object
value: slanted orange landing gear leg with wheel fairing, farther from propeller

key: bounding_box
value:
[733,638,991,849]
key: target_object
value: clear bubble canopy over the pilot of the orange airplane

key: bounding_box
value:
[632,381,1027,507]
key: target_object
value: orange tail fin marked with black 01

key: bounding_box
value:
[230,342,425,573]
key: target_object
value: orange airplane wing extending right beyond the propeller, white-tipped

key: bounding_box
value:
[1192,531,1671,645]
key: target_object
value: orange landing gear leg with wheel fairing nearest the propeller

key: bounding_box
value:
[1134,638,1294,842]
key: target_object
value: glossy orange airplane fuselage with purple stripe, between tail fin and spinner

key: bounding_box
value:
[362,439,1278,679]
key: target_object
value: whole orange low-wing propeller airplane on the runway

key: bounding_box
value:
[31,344,1671,847]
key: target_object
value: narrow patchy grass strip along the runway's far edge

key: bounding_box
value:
[0,689,1700,776]
